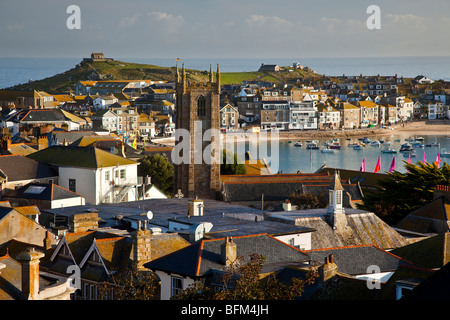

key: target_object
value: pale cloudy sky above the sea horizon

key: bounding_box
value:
[0,0,450,58]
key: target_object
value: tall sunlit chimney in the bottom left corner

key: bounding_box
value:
[16,248,44,300]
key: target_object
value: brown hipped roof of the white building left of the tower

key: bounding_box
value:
[28,146,138,169]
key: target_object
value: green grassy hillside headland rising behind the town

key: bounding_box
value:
[8,60,314,94]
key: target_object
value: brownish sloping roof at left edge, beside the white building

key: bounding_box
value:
[0,155,58,181]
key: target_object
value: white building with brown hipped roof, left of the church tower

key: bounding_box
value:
[30,146,139,205]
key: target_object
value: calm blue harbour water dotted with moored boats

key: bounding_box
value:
[246,133,450,173]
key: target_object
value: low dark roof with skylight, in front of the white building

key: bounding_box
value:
[3,183,82,201]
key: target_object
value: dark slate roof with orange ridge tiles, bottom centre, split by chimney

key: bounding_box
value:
[144,234,309,278]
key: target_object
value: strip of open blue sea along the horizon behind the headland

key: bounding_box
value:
[0,56,450,89]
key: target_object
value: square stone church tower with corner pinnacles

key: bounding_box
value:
[172,64,221,199]
